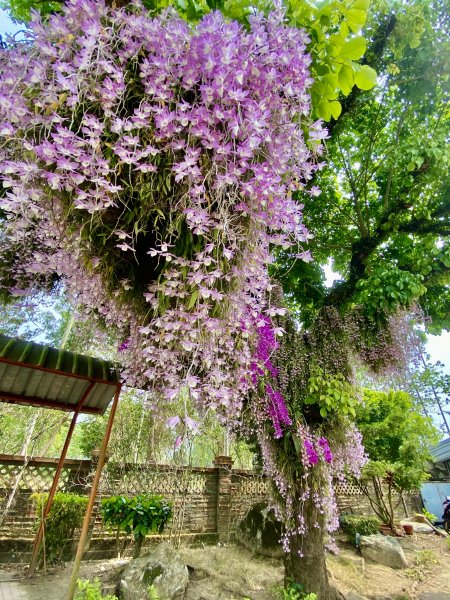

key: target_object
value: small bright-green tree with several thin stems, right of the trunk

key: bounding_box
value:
[356,390,439,528]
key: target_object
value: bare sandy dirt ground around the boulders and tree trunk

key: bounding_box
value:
[0,534,450,600]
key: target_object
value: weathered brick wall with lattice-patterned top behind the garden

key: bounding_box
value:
[0,455,420,562]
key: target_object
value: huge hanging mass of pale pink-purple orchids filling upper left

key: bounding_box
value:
[0,0,325,423]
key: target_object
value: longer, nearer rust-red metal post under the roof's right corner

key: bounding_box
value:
[67,387,120,600]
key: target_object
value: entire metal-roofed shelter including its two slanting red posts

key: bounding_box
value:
[0,335,122,600]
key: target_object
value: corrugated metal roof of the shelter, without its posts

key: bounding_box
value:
[0,335,121,414]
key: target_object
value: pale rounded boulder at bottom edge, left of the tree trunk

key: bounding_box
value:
[120,542,189,600]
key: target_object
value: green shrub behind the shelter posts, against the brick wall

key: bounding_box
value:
[31,492,88,564]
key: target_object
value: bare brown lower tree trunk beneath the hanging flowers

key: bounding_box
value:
[284,494,338,600]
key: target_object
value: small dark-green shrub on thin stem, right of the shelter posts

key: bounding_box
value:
[101,494,172,558]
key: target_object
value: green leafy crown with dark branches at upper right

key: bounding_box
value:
[275,1,450,335]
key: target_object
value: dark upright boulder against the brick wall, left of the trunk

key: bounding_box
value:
[235,502,283,558]
